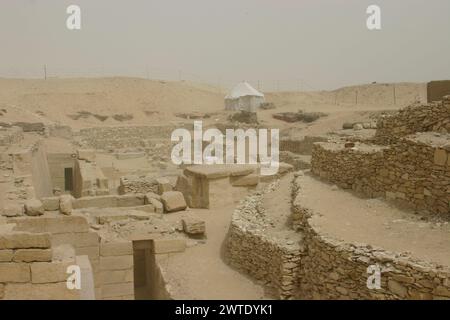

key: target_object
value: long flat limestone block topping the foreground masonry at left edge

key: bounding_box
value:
[0,232,50,249]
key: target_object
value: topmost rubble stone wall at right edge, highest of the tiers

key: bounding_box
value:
[375,96,450,143]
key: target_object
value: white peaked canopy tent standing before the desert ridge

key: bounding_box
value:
[225,81,264,112]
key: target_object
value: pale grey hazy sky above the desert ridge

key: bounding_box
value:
[0,0,450,89]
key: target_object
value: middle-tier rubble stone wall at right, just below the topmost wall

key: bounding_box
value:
[311,133,450,214]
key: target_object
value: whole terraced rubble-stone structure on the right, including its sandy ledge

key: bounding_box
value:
[227,97,450,300]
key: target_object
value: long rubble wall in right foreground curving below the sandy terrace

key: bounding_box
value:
[292,175,450,299]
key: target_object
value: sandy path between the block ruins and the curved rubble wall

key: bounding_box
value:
[158,205,267,300]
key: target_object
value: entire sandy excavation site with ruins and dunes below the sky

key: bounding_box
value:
[0,79,450,300]
